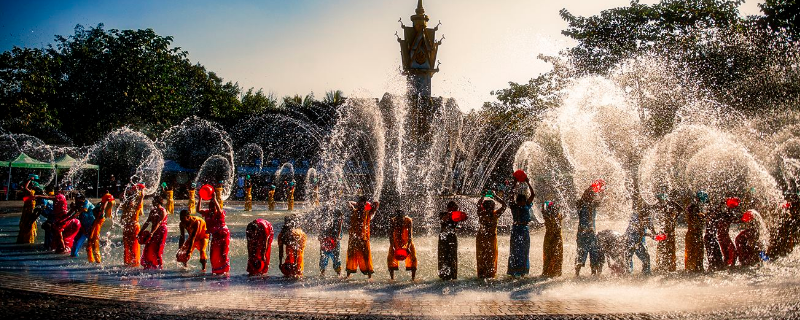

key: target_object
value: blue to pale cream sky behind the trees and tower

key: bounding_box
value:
[0,0,763,111]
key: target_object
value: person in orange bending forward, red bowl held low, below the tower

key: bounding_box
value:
[386,210,417,281]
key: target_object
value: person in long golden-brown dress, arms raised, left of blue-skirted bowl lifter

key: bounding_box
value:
[475,192,506,279]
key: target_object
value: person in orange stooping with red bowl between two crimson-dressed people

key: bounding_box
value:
[175,209,208,272]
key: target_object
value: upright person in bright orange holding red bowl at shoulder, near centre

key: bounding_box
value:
[345,196,380,279]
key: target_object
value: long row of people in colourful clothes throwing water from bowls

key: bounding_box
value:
[10,170,800,280]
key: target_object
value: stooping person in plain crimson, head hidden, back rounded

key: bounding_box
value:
[246,219,274,276]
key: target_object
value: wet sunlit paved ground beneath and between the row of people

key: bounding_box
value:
[0,203,800,319]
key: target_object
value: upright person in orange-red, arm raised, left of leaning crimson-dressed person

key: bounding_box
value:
[122,184,144,267]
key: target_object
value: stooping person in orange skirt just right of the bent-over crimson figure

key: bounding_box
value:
[278,216,307,278]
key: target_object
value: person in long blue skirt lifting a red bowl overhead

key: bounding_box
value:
[507,179,534,278]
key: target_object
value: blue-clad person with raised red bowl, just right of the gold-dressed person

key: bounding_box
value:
[575,180,605,277]
